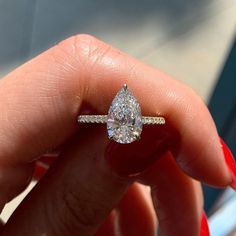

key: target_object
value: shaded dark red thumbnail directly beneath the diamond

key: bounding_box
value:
[105,126,178,176]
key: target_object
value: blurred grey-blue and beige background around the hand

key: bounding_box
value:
[0,0,236,235]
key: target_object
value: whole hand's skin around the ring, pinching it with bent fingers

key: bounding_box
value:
[0,35,232,236]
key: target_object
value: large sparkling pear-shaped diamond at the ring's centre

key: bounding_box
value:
[107,85,143,143]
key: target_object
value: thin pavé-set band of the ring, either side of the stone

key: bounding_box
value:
[78,115,166,125]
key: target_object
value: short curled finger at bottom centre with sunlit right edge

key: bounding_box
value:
[118,183,157,236]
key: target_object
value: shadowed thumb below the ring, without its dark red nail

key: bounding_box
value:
[3,126,164,235]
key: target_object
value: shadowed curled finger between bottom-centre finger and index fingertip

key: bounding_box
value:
[143,153,203,236]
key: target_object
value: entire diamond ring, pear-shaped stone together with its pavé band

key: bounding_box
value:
[78,84,166,143]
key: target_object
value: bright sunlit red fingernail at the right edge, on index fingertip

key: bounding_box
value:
[220,138,236,190]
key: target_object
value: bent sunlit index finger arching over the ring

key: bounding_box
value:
[0,35,232,186]
